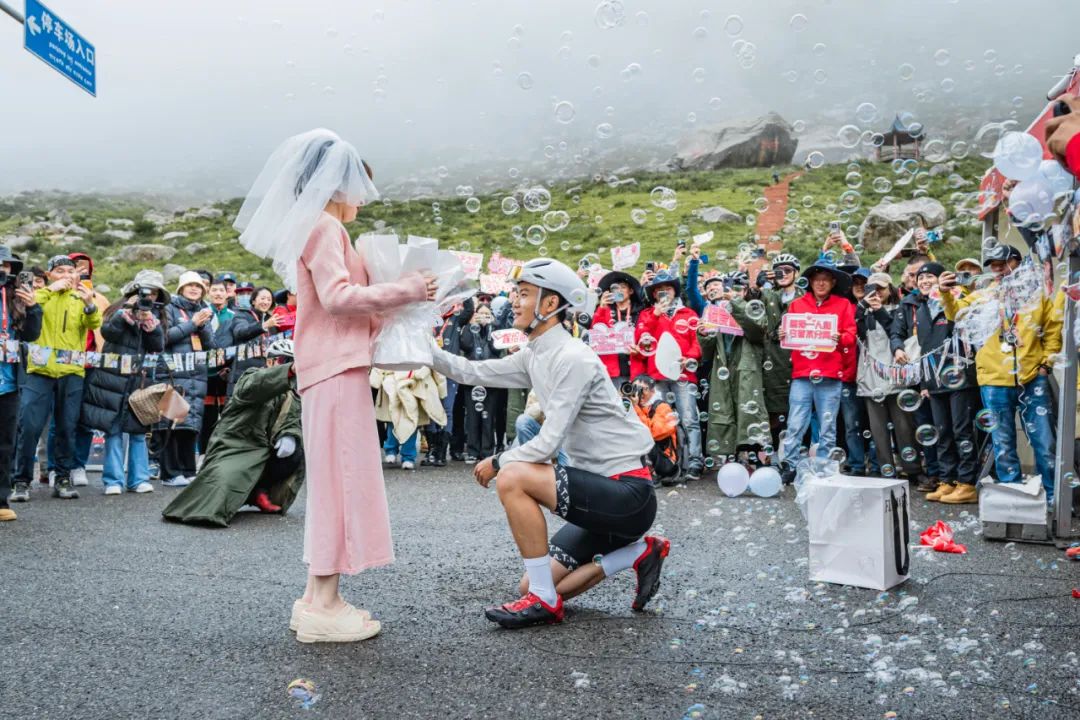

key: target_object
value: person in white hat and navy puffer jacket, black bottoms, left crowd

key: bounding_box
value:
[153,271,215,488]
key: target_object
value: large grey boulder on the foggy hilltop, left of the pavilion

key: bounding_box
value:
[669,112,798,171]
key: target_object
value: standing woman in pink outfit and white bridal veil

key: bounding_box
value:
[235,130,435,642]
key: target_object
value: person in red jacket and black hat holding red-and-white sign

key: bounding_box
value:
[780,260,855,483]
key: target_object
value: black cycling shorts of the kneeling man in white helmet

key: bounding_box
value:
[548,464,657,570]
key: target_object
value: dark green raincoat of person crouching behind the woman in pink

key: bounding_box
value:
[162,364,303,527]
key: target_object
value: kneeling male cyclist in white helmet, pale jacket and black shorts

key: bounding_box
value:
[425,258,671,628]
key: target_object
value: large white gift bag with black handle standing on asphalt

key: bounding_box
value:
[804,475,912,590]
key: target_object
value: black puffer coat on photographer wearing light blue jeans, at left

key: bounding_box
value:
[80,310,165,435]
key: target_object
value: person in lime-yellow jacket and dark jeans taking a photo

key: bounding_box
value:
[12,255,102,501]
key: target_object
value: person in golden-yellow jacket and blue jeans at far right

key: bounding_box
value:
[940,245,1065,503]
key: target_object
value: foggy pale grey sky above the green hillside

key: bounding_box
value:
[0,0,1080,200]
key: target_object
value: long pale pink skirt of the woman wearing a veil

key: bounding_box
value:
[301,367,394,575]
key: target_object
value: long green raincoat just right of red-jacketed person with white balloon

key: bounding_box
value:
[698,303,769,456]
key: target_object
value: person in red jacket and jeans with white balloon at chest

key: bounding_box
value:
[634,270,704,480]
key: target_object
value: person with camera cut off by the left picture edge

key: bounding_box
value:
[0,245,41,521]
